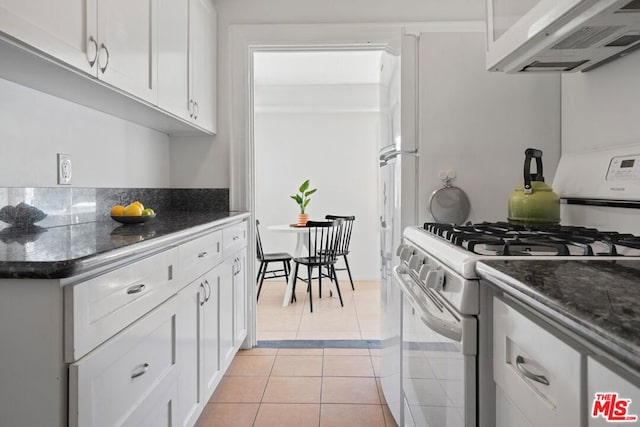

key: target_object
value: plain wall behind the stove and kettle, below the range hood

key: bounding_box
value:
[418,32,560,222]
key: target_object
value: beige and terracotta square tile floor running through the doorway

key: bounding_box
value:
[192,280,397,427]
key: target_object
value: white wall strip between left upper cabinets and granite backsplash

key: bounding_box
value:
[0,79,170,188]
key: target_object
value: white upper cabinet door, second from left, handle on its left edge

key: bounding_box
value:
[97,0,158,104]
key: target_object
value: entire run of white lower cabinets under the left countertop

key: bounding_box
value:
[0,217,248,427]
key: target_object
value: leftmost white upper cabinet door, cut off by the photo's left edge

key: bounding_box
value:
[0,0,98,76]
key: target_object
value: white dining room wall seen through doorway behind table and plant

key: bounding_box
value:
[255,85,380,280]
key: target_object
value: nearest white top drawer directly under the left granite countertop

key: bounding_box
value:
[65,249,180,362]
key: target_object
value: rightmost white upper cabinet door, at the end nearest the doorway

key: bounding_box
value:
[189,0,217,133]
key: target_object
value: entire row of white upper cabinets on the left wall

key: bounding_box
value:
[0,0,217,135]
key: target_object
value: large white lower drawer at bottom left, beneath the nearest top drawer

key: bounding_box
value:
[69,298,178,427]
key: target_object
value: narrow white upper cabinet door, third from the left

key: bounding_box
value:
[158,0,191,120]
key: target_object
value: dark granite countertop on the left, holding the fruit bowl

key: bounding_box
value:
[0,211,248,279]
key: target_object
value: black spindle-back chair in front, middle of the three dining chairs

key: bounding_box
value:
[292,220,344,313]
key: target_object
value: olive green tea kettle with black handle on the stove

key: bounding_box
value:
[507,148,560,227]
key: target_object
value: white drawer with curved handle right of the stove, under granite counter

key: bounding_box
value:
[493,298,584,427]
